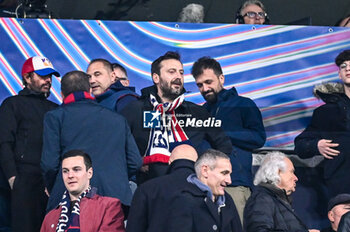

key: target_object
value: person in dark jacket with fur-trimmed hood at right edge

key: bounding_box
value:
[294,50,350,199]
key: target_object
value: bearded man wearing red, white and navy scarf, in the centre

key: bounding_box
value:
[121,52,232,183]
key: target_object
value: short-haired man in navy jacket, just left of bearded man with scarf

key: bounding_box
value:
[86,59,138,113]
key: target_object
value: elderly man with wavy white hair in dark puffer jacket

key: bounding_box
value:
[244,152,319,232]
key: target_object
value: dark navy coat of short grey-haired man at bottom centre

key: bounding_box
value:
[165,183,242,232]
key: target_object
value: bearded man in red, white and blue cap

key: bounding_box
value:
[0,56,59,232]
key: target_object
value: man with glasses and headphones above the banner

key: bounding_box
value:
[236,0,269,24]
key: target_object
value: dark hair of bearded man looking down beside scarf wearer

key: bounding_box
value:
[191,56,222,79]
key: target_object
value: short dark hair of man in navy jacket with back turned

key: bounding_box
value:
[61,71,90,97]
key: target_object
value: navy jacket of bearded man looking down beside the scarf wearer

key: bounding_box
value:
[204,87,266,187]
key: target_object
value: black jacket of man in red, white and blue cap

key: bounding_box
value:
[0,88,57,179]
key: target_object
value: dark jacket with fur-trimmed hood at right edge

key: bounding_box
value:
[294,83,350,181]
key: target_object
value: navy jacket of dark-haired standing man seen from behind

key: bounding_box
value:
[41,96,142,210]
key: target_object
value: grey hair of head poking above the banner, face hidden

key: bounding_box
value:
[177,3,204,23]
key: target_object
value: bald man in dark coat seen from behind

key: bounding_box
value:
[126,144,198,232]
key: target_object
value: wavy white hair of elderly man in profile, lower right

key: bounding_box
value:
[254,151,287,186]
